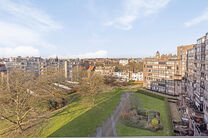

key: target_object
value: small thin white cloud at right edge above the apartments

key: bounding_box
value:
[184,9,208,27]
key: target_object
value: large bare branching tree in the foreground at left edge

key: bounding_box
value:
[0,70,41,134]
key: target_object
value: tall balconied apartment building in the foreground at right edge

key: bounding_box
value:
[180,34,208,136]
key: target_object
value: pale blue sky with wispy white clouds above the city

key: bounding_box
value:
[0,0,208,58]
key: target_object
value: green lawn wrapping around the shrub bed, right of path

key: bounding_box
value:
[117,92,173,136]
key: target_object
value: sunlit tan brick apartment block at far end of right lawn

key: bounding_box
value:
[143,52,181,95]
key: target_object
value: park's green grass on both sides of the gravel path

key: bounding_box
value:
[39,89,173,137]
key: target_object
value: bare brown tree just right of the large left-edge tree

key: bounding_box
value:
[33,67,70,108]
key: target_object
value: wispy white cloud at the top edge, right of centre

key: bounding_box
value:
[104,0,170,30]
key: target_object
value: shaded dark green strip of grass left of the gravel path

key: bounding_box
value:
[50,89,128,137]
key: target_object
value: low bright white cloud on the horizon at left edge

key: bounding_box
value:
[0,46,40,57]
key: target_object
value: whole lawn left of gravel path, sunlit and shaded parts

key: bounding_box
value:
[36,89,128,137]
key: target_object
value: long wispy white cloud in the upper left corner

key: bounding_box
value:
[0,0,62,31]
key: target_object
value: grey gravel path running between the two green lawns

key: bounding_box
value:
[95,92,132,137]
